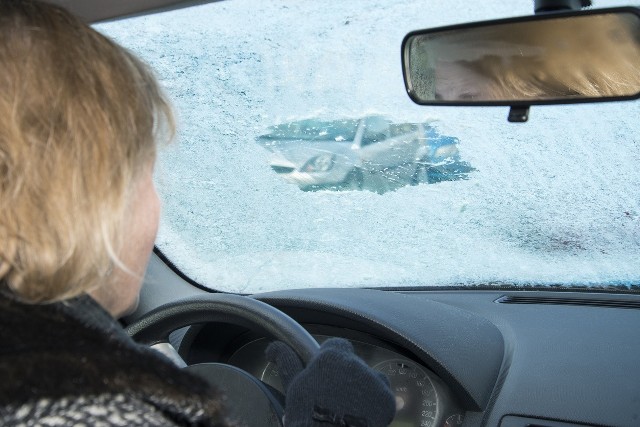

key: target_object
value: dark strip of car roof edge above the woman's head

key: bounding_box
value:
[45,0,221,23]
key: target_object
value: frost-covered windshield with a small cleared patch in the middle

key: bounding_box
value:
[96,0,640,293]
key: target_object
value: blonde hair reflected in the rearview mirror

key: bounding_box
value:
[460,14,640,99]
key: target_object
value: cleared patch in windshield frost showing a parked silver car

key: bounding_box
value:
[256,116,472,193]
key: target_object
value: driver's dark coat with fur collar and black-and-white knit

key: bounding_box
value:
[0,290,232,426]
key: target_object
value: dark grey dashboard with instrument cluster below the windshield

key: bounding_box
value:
[161,289,640,427]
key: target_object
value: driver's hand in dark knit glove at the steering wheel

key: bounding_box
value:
[266,338,396,427]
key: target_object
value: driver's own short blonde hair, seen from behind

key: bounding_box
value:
[0,0,174,302]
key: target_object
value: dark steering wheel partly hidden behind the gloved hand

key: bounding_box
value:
[126,294,320,427]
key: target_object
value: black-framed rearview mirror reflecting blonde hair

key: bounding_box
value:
[402,8,640,106]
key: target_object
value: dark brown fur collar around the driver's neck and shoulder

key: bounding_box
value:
[0,291,230,425]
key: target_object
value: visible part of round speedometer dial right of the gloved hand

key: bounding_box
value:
[374,359,440,427]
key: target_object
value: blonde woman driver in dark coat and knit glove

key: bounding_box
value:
[0,0,395,426]
